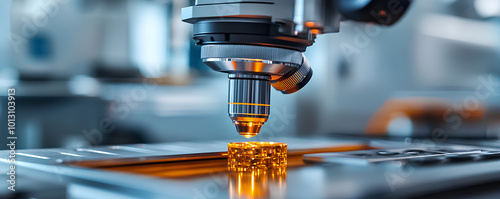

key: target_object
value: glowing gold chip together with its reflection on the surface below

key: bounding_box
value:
[227,142,287,198]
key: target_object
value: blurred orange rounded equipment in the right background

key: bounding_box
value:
[366,97,486,138]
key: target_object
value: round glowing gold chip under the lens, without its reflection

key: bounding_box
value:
[227,142,287,171]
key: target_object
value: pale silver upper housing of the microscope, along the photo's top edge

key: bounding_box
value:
[182,0,341,33]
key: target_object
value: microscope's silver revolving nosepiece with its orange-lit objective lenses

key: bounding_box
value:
[201,44,312,138]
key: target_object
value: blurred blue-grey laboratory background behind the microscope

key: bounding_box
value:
[0,0,500,149]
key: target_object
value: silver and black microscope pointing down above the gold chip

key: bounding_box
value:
[182,0,411,138]
